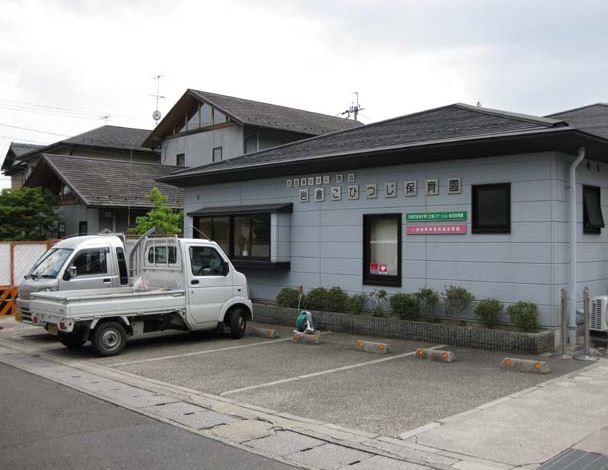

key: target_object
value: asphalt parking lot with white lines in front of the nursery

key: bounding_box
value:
[0,320,585,436]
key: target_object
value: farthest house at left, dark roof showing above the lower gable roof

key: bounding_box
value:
[2,126,160,189]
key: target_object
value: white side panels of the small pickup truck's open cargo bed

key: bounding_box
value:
[30,287,186,322]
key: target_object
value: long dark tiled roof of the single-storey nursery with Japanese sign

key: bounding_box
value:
[162,103,600,186]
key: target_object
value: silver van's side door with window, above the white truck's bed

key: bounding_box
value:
[59,247,118,290]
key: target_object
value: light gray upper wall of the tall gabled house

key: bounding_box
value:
[161,125,243,167]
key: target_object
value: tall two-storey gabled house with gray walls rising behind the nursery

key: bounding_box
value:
[143,89,362,167]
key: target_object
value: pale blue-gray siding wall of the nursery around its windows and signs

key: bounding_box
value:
[185,153,608,326]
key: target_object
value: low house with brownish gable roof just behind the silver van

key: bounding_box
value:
[27,154,183,235]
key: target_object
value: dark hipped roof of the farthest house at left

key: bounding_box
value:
[20,125,158,159]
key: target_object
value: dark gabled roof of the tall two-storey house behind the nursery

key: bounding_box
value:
[144,89,363,147]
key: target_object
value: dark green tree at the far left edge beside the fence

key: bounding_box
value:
[0,187,59,240]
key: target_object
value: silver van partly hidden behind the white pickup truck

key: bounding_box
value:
[17,235,129,322]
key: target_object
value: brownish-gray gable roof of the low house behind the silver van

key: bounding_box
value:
[26,154,183,208]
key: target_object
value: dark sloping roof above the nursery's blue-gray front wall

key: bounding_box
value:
[163,103,566,186]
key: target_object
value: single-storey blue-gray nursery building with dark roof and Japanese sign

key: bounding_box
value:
[160,104,608,327]
